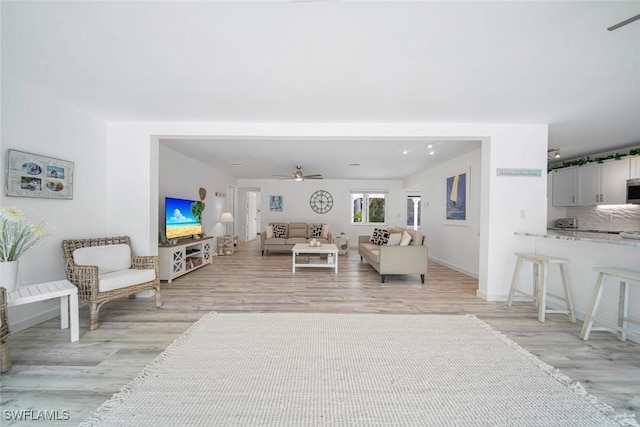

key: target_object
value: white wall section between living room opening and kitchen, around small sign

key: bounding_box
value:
[478,129,548,301]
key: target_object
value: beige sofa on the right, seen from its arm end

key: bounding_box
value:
[358,227,429,283]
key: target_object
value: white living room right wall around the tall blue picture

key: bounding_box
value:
[420,143,481,277]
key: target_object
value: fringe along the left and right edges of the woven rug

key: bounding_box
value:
[79,312,640,427]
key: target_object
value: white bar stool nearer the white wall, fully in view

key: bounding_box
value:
[507,253,576,323]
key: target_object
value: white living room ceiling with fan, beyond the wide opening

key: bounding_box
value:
[160,138,480,179]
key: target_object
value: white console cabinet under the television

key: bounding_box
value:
[158,237,213,283]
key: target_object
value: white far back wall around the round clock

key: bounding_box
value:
[239,179,406,246]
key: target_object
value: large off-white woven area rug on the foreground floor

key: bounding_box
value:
[82,313,637,427]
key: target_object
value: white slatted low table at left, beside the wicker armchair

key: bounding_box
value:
[7,280,80,342]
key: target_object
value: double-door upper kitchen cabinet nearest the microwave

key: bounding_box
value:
[578,158,629,206]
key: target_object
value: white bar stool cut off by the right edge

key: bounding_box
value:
[580,267,640,341]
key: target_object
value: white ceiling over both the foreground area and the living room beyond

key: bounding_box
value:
[1,0,640,178]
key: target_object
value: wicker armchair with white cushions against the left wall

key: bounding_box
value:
[62,236,162,331]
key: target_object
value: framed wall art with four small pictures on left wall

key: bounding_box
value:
[5,149,73,200]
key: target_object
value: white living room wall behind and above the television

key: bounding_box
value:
[158,145,236,245]
